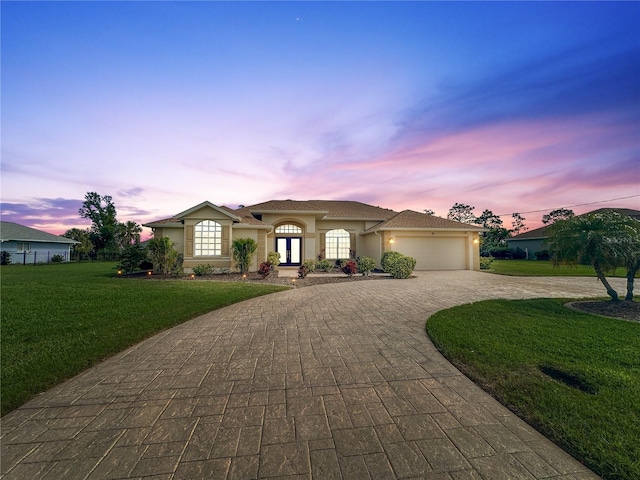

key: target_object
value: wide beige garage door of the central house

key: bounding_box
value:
[394,237,467,270]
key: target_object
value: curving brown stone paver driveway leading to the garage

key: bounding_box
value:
[1,272,623,480]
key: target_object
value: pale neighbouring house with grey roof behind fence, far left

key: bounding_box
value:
[0,222,79,264]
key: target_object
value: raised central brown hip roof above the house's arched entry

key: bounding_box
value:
[242,200,396,221]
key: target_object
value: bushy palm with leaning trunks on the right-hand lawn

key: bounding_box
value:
[546,211,640,301]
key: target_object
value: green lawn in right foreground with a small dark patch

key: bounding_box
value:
[427,299,640,479]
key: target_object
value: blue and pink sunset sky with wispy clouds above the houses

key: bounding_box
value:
[1,1,640,233]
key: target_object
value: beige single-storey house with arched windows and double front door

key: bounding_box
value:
[144,200,484,271]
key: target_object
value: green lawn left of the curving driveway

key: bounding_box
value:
[0,263,286,415]
